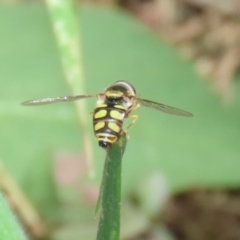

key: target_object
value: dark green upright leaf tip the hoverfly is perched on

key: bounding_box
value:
[97,133,127,240]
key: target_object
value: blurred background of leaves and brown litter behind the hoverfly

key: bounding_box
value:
[0,0,240,240]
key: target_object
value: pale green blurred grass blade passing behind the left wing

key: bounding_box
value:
[45,0,94,175]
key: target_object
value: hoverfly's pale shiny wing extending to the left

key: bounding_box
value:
[21,95,97,106]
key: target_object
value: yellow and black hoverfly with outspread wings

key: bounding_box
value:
[22,80,193,149]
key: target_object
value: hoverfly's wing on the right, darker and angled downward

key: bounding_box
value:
[137,98,193,117]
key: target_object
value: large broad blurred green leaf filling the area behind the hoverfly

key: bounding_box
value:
[0,4,240,234]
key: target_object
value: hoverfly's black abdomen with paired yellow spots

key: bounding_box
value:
[93,104,126,148]
